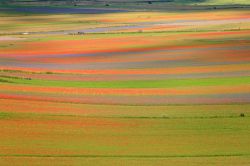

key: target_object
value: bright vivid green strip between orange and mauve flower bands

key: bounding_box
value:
[0,77,250,88]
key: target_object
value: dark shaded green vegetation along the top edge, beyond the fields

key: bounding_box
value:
[0,0,250,10]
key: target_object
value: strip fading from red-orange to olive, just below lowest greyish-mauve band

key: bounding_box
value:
[0,99,250,118]
